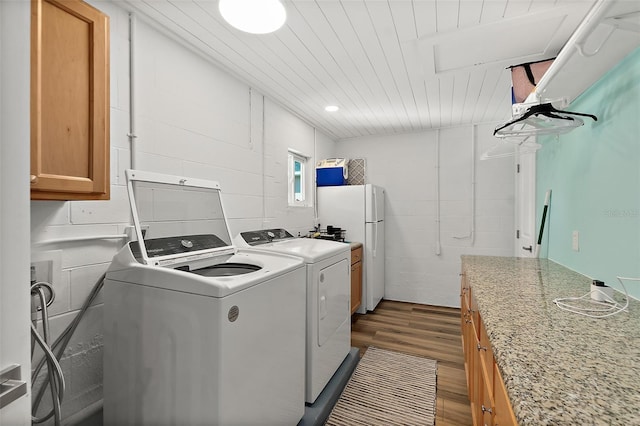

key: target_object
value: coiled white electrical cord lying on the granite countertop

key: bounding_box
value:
[553,277,640,318]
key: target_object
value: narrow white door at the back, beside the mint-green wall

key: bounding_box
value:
[514,149,537,257]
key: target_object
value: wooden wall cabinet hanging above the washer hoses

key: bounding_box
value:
[31,0,110,200]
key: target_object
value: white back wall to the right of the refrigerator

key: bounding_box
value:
[336,124,515,307]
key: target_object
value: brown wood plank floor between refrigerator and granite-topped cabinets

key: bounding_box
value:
[351,300,472,426]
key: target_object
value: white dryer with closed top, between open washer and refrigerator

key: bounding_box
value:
[235,229,351,404]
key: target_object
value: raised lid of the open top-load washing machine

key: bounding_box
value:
[126,170,235,266]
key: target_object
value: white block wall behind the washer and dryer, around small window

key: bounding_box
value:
[31,1,335,418]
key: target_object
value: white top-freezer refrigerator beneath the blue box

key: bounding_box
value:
[318,184,385,313]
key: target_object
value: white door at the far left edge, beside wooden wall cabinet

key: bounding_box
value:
[0,0,31,426]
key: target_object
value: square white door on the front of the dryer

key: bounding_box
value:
[314,259,351,346]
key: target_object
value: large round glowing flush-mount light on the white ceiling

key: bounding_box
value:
[218,0,287,34]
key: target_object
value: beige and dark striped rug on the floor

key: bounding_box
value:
[325,346,437,426]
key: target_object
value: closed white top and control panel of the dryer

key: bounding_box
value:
[236,228,351,263]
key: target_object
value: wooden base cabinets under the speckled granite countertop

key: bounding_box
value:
[460,274,518,426]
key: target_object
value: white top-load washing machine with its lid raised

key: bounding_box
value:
[103,171,306,425]
